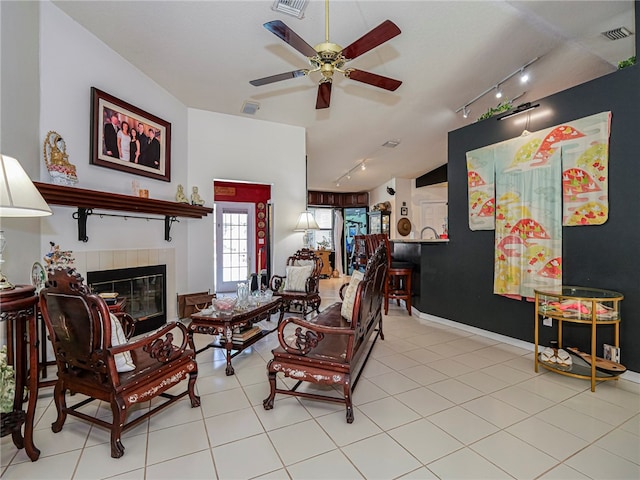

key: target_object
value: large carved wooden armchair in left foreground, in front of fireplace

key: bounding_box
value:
[40,268,200,458]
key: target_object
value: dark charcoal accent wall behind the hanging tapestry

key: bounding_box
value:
[430,46,640,372]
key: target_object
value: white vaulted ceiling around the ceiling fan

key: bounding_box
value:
[54,0,636,191]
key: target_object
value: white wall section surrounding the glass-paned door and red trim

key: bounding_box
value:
[187,109,307,291]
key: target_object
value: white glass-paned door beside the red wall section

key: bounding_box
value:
[215,202,255,292]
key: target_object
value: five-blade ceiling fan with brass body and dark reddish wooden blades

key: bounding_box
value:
[249,0,402,109]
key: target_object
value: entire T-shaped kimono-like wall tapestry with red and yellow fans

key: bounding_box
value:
[467,112,611,297]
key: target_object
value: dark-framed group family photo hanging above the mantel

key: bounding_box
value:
[91,87,171,182]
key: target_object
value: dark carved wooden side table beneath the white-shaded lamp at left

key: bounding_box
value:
[0,285,40,462]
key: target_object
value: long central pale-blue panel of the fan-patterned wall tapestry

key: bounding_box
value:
[493,137,562,298]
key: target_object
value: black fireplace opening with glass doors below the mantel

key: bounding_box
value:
[87,265,167,335]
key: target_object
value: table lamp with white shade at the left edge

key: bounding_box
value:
[0,155,52,290]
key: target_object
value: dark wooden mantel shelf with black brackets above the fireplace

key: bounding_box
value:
[34,182,213,242]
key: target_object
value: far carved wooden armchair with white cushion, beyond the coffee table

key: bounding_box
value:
[269,248,322,320]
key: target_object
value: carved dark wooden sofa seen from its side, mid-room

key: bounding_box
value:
[263,244,387,423]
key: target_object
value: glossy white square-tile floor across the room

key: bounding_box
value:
[1,280,640,480]
